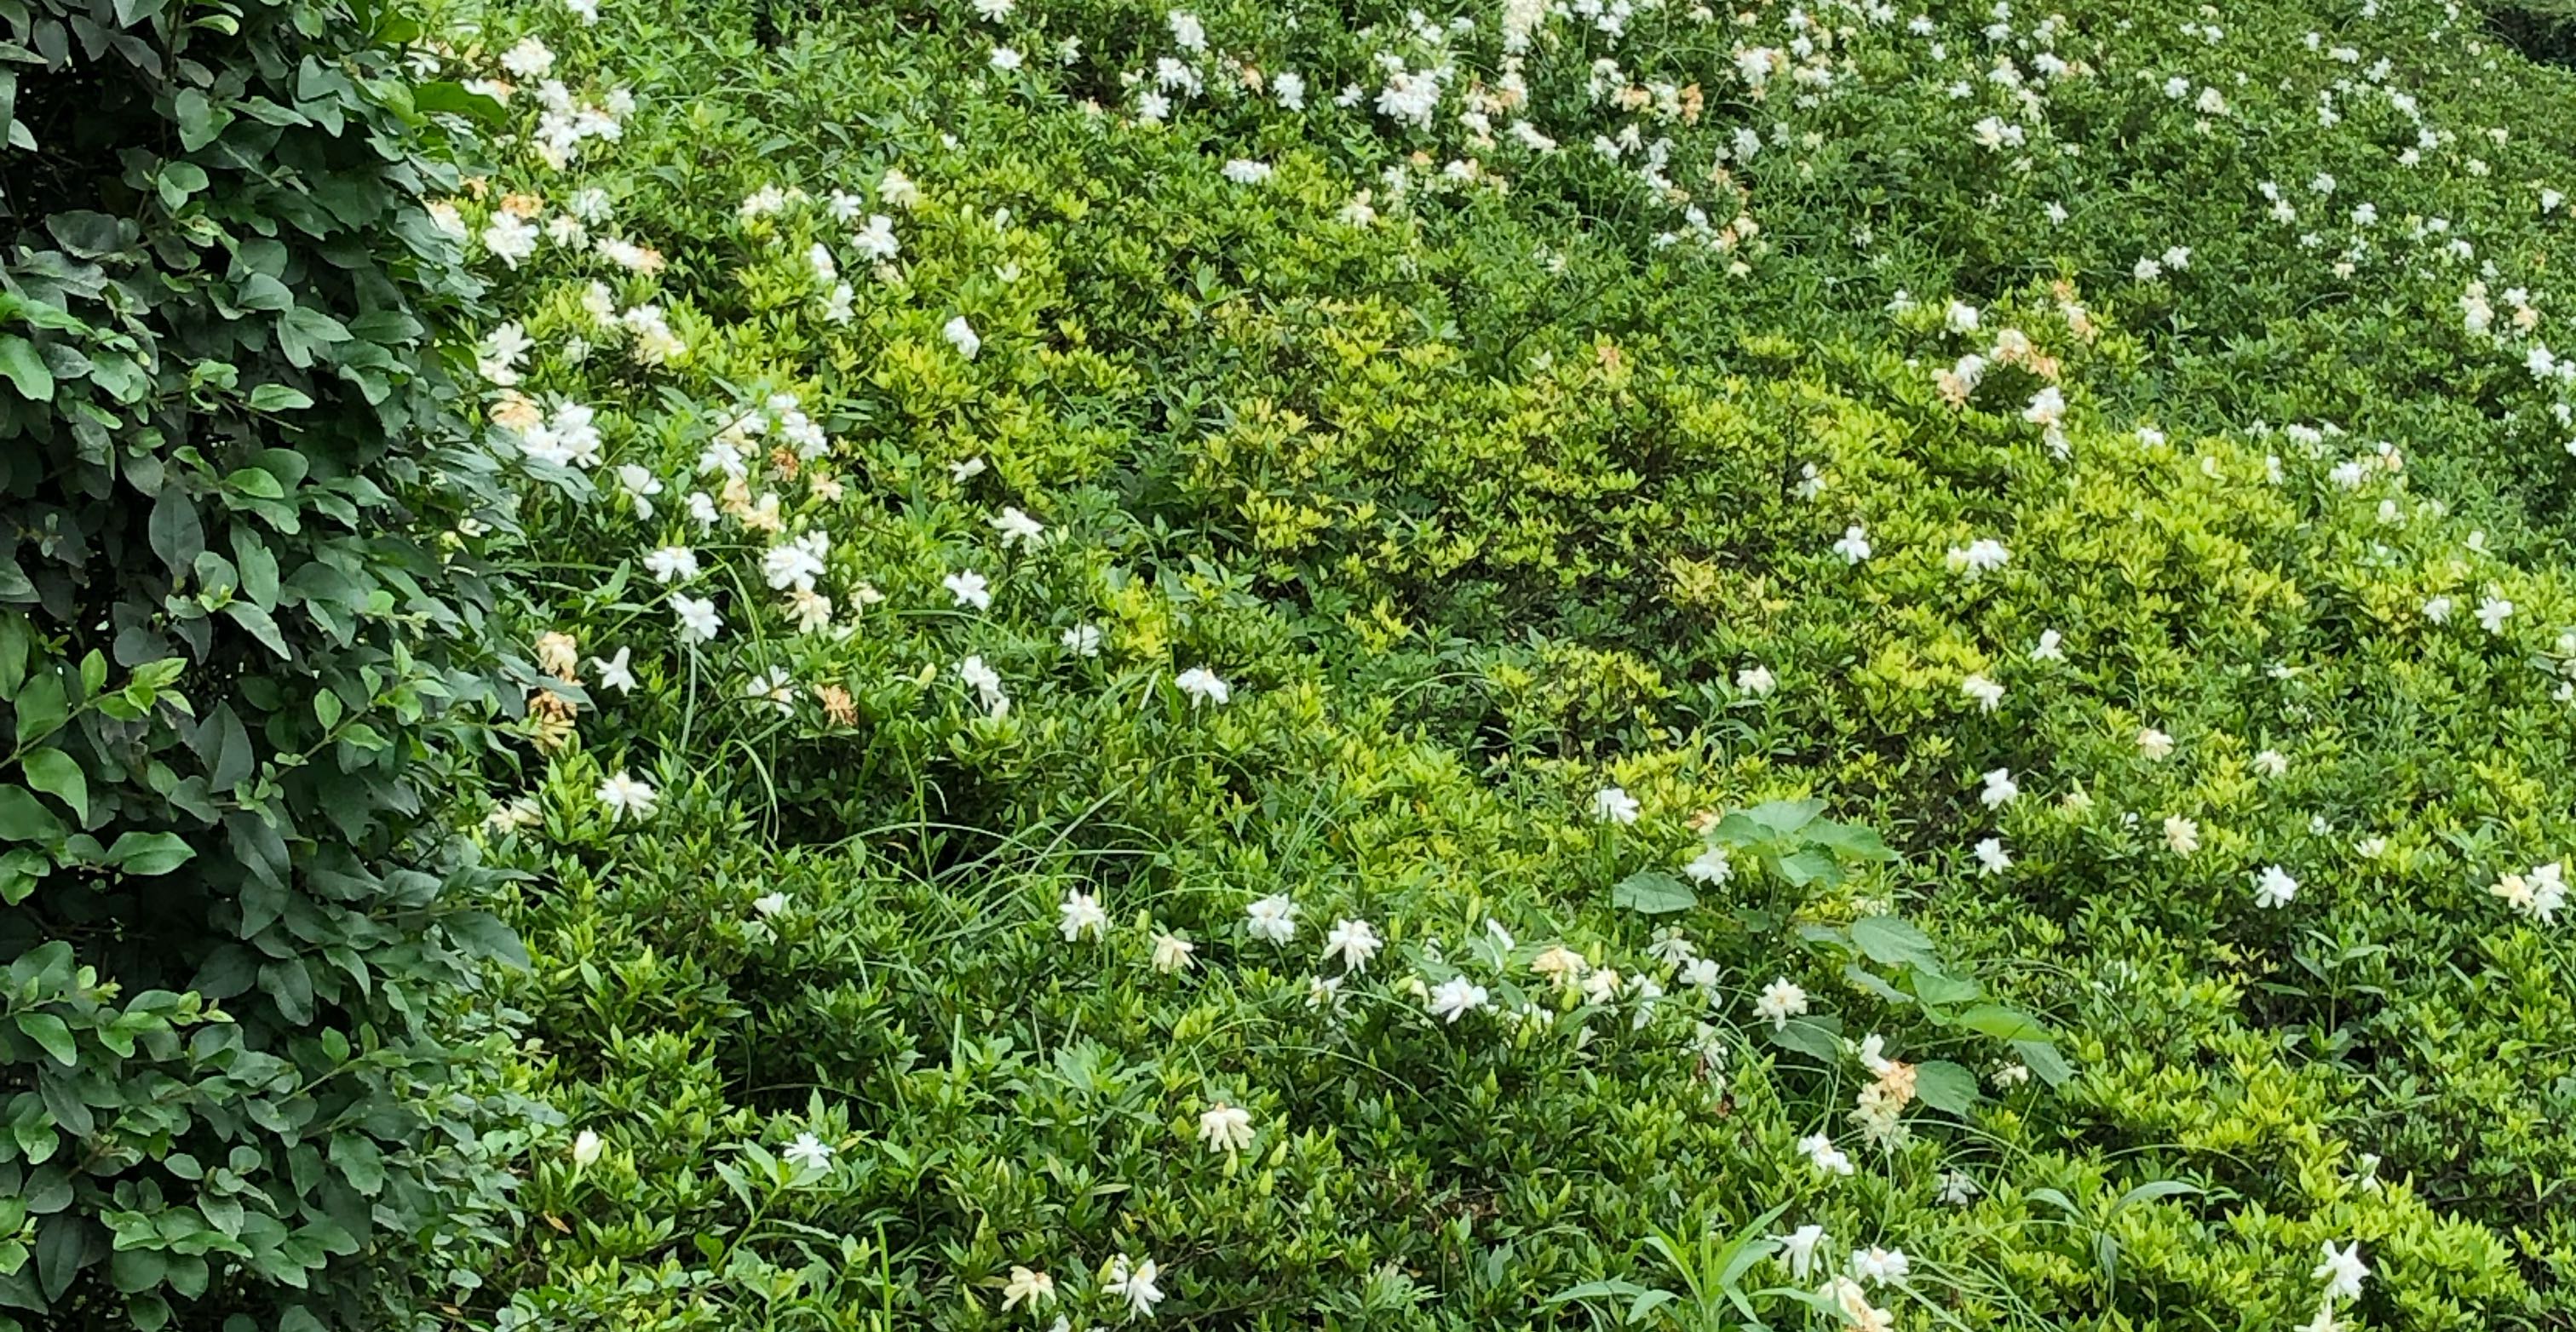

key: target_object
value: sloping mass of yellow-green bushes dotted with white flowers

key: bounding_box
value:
[342,0,2576,1329]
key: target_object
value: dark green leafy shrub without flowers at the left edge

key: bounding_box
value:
[0,0,532,1329]
